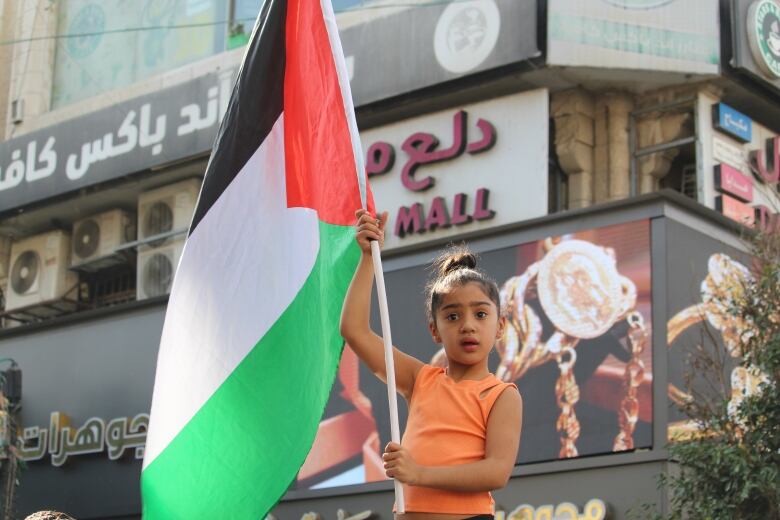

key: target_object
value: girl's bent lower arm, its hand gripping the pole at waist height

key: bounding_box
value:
[382,388,523,492]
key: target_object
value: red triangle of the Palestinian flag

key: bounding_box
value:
[284,0,372,225]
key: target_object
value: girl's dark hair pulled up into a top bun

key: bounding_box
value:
[425,244,501,321]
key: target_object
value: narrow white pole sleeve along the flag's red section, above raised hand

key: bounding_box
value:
[320,0,368,208]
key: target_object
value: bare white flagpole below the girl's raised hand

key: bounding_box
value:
[371,240,406,513]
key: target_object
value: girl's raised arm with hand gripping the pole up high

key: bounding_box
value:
[340,210,423,400]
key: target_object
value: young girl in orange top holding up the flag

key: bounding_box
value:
[341,210,522,520]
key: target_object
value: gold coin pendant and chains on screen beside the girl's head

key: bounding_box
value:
[496,240,647,458]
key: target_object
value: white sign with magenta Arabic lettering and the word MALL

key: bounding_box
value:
[361,90,548,250]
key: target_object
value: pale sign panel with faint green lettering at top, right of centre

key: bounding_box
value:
[547,0,720,74]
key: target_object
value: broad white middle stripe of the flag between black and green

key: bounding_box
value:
[144,115,319,468]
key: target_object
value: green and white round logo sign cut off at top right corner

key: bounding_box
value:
[747,0,780,79]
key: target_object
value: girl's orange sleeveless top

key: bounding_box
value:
[401,365,517,515]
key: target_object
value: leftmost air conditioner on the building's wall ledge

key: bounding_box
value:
[5,231,78,311]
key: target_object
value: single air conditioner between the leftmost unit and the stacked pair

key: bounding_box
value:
[70,209,135,267]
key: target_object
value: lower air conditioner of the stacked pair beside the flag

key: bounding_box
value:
[136,237,185,300]
